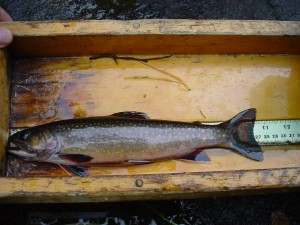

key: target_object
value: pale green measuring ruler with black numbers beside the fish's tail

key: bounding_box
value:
[254,120,300,145]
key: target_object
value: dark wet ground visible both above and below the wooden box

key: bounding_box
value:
[0,0,300,225]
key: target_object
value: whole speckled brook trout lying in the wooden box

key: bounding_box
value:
[9,109,263,176]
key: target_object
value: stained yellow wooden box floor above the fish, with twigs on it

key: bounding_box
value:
[11,55,300,127]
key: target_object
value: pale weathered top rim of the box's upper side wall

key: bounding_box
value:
[1,19,300,36]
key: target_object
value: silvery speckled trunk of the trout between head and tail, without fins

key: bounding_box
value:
[41,119,228,162]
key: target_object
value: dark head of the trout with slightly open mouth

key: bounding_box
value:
[8,128,59,161]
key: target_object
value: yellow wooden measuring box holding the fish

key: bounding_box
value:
[0,20,300,203]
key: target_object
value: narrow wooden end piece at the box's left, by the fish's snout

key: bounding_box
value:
[0,49,10,175]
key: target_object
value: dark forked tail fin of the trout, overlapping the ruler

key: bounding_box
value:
[223,108,263,161]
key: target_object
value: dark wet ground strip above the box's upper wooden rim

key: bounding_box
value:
[0,0,300,21]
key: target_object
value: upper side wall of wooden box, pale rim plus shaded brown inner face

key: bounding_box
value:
[1,20,300,56]
